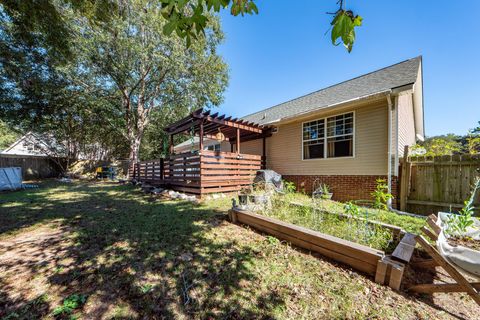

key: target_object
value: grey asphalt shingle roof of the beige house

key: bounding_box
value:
[242,57,422,124]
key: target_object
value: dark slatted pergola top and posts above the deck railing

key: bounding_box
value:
[164,108,271,156]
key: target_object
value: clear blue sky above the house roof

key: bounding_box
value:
[219,0,480,136]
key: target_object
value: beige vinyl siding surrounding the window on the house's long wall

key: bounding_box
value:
[266,100,388,175]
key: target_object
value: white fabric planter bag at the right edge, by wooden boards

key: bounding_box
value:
[437,212,480,278]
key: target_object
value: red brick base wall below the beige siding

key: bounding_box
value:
[283,175,398,204]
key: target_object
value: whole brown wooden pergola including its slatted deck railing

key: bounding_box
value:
[131,109,271,196]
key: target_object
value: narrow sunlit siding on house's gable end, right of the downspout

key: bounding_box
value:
[398,93,416,157]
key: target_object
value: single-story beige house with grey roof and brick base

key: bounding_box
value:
[172,57,425,200]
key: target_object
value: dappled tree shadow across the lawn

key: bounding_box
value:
[0,184,284,319]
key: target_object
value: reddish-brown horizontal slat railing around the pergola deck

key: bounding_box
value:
[129,151,262,194]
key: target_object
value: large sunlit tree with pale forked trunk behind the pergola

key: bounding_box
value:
[66,0,228,161]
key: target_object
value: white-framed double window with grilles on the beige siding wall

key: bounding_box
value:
[303,112,354,159]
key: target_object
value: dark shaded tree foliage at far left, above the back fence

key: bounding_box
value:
[0,5,129,164]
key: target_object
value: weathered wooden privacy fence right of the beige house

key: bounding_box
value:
[399,148,480,215]
